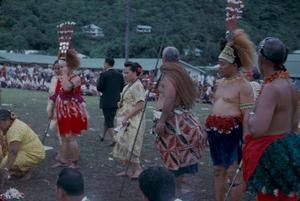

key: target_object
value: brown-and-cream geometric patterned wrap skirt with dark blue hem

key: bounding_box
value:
[153,108,204,176]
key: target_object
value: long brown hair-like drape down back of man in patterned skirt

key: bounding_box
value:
[160,62,197,109]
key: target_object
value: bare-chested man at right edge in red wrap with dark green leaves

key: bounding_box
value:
[243,37,300,201]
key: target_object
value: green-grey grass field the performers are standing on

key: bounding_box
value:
[1,89,254,201]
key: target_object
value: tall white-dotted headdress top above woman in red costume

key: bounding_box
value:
[57,22,76,60]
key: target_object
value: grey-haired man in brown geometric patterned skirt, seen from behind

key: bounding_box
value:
[154,47,206,194]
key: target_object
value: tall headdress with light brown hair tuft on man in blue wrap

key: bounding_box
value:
[219,0,255,70]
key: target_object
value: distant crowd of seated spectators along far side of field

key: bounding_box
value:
[0,65,215,103]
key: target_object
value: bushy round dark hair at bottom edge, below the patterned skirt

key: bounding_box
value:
[139,166,175,201]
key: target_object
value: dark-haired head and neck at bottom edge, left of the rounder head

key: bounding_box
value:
[56,168,89,201]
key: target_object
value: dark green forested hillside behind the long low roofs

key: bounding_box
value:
[0,0,300,65]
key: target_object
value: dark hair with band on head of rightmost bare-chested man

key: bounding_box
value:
[258,37,288,70]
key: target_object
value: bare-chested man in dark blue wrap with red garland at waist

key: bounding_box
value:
[206,30,255,201]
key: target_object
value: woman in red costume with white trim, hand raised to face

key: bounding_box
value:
[49,49,88,168]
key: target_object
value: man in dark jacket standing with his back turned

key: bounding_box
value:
[97,58,124,146]
